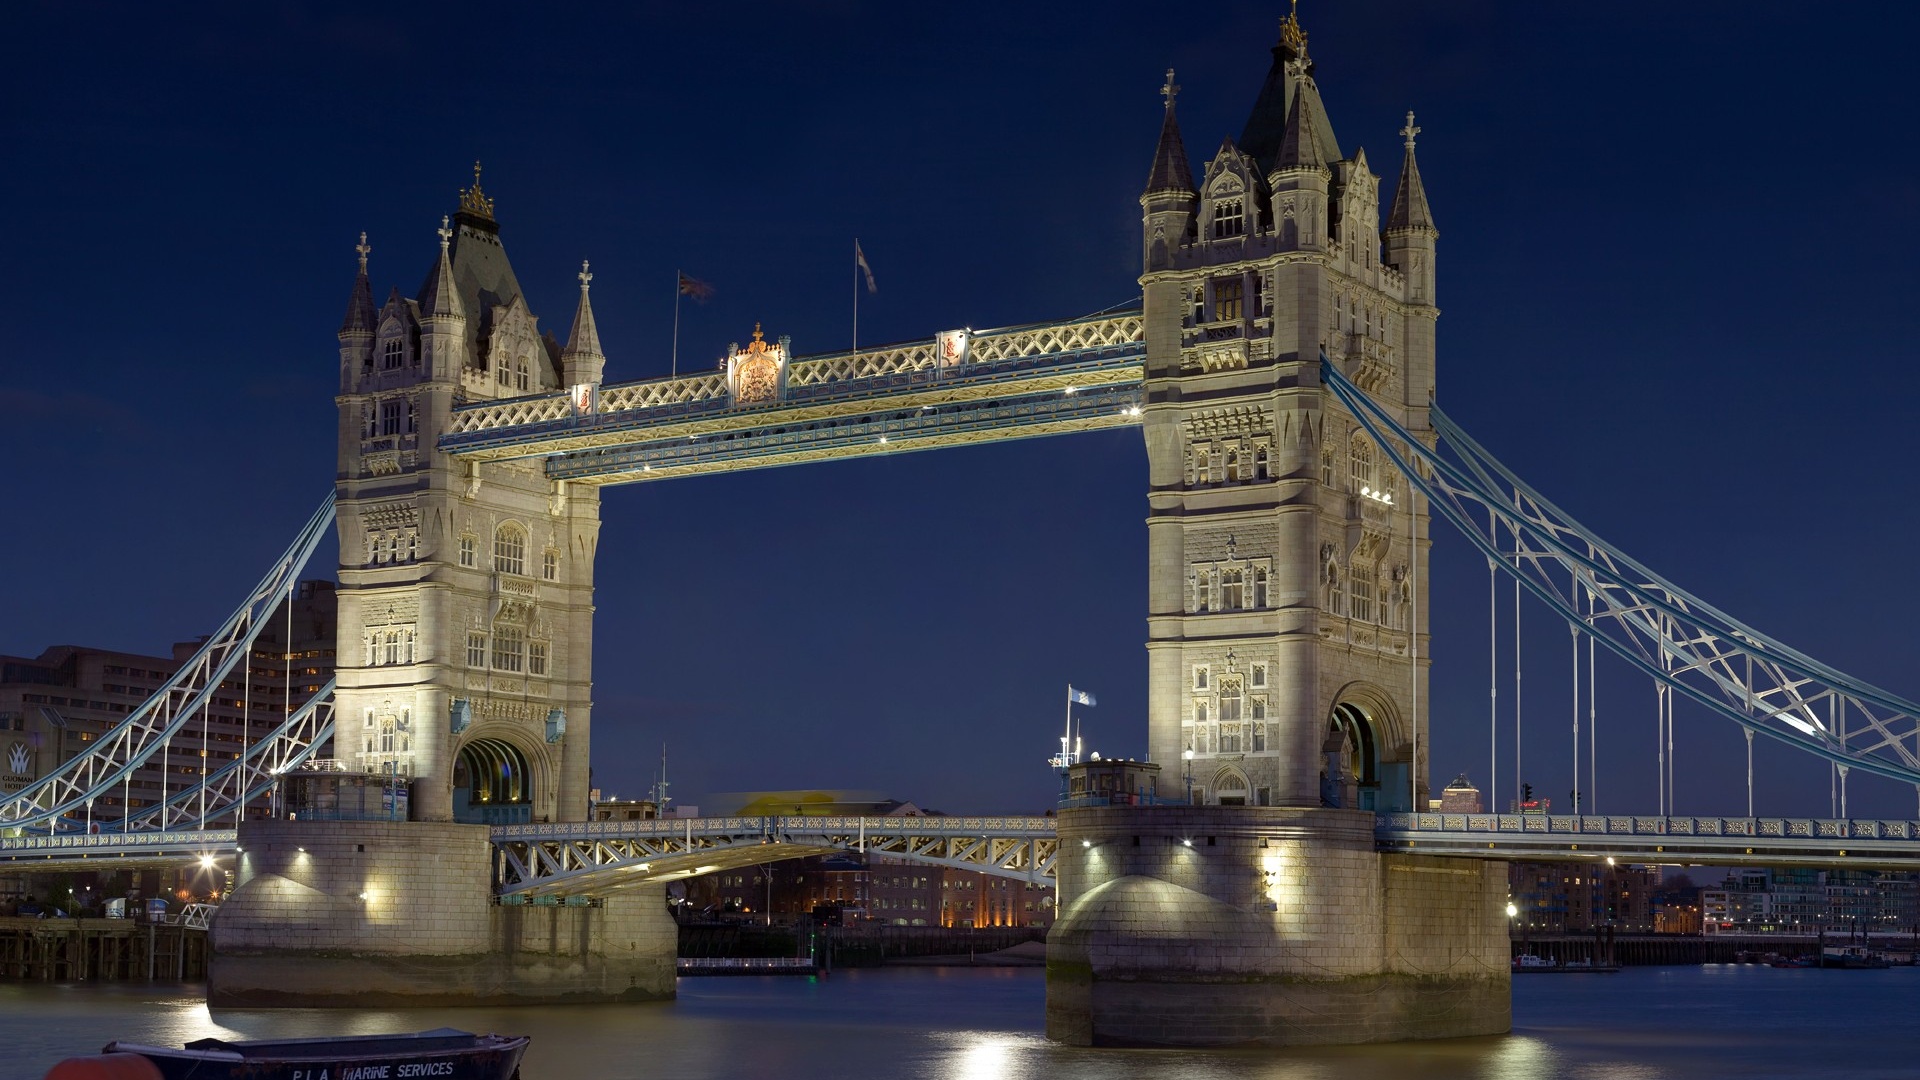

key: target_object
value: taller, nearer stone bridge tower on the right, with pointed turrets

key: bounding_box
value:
[1140,15,1438,809]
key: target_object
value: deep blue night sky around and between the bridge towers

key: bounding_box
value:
[0,0,1920,817]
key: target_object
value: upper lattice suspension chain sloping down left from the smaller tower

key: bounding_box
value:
[0,494,334,830]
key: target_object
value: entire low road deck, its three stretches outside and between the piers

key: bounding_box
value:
[0,813,1920,887]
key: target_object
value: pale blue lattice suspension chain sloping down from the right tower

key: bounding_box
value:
[1321,361,1920,788]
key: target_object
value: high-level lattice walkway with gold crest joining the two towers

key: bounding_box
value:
[438,311,1146,484]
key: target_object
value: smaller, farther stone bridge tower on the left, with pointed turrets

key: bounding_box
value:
[334,165,605,824]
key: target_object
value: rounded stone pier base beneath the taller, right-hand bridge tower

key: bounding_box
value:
[1046,807,1513,1047]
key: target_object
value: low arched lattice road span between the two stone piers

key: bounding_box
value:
[493,817,1060,897]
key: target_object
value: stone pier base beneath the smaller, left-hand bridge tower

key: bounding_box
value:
[207,821,678,1009]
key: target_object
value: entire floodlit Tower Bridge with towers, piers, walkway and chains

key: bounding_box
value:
[0,6,1920,1045]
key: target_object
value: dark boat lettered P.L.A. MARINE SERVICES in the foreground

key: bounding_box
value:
[46,1028,528,1080]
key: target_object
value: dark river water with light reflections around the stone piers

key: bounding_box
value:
[0,965,1920,1080]
